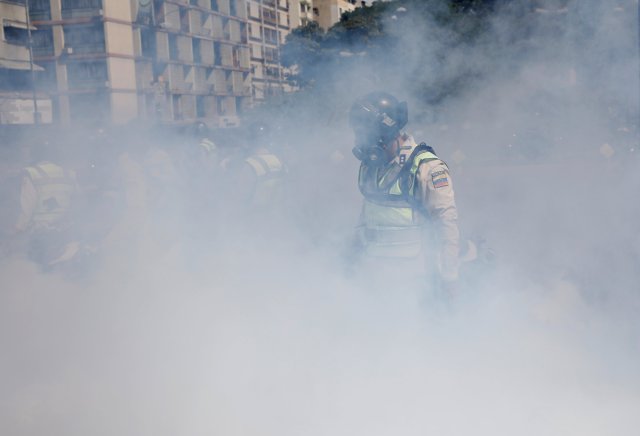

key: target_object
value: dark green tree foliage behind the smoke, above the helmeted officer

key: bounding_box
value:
[282,0,496,101]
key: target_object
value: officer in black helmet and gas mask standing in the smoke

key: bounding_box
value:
[349,92,460,296]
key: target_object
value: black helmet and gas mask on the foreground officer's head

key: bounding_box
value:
[349,92,408,165]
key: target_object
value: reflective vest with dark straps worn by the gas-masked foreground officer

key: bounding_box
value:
[358,144,438,257]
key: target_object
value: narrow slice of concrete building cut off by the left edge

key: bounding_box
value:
[0,0,51,124]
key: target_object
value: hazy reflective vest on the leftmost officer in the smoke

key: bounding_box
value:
[25,162,76,229]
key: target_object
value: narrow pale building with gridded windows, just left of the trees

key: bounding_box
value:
[247,0,291,101]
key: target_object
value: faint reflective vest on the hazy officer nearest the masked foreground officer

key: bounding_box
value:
[245,153,286,207]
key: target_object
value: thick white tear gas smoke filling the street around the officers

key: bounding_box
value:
[0,1,640,436]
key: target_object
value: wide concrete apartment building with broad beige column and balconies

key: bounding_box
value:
[30,0,251,126]
